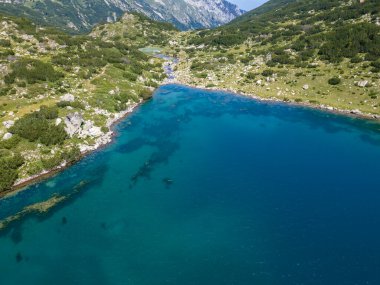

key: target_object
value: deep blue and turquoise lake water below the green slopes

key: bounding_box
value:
[0,85,380,285]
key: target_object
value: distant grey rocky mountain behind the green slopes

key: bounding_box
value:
[0,0,243,32]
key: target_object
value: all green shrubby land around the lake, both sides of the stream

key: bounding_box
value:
[0,0,380,192]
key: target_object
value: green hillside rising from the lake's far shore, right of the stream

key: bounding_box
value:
[172,0,380,114]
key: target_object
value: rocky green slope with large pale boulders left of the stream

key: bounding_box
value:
[0,14,176,191]
